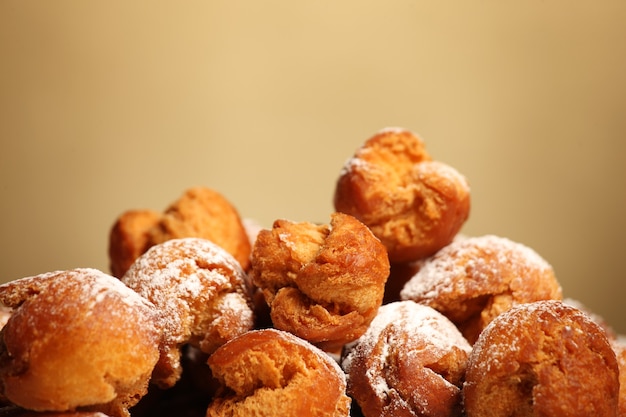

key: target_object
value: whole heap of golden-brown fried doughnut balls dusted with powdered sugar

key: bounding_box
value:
[0,128,626,417]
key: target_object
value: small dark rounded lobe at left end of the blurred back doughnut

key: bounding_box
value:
[109,210,161,278]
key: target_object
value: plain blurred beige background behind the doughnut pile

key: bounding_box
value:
[0,0,626,332]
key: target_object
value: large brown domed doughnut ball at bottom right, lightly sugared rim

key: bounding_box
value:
[463,300,620,417]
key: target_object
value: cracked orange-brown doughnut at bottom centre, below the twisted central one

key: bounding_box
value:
[206,329,350,417]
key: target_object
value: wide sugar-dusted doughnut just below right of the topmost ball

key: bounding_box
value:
[400,235,562,343]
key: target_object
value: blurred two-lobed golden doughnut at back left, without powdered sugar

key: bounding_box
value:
[108,187,251,278]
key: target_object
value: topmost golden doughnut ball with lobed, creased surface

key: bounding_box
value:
[334,129,470,263]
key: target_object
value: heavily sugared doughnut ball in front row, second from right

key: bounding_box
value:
[341,301,471,417]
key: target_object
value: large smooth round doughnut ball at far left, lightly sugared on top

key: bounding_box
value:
[0,269,161,417]
